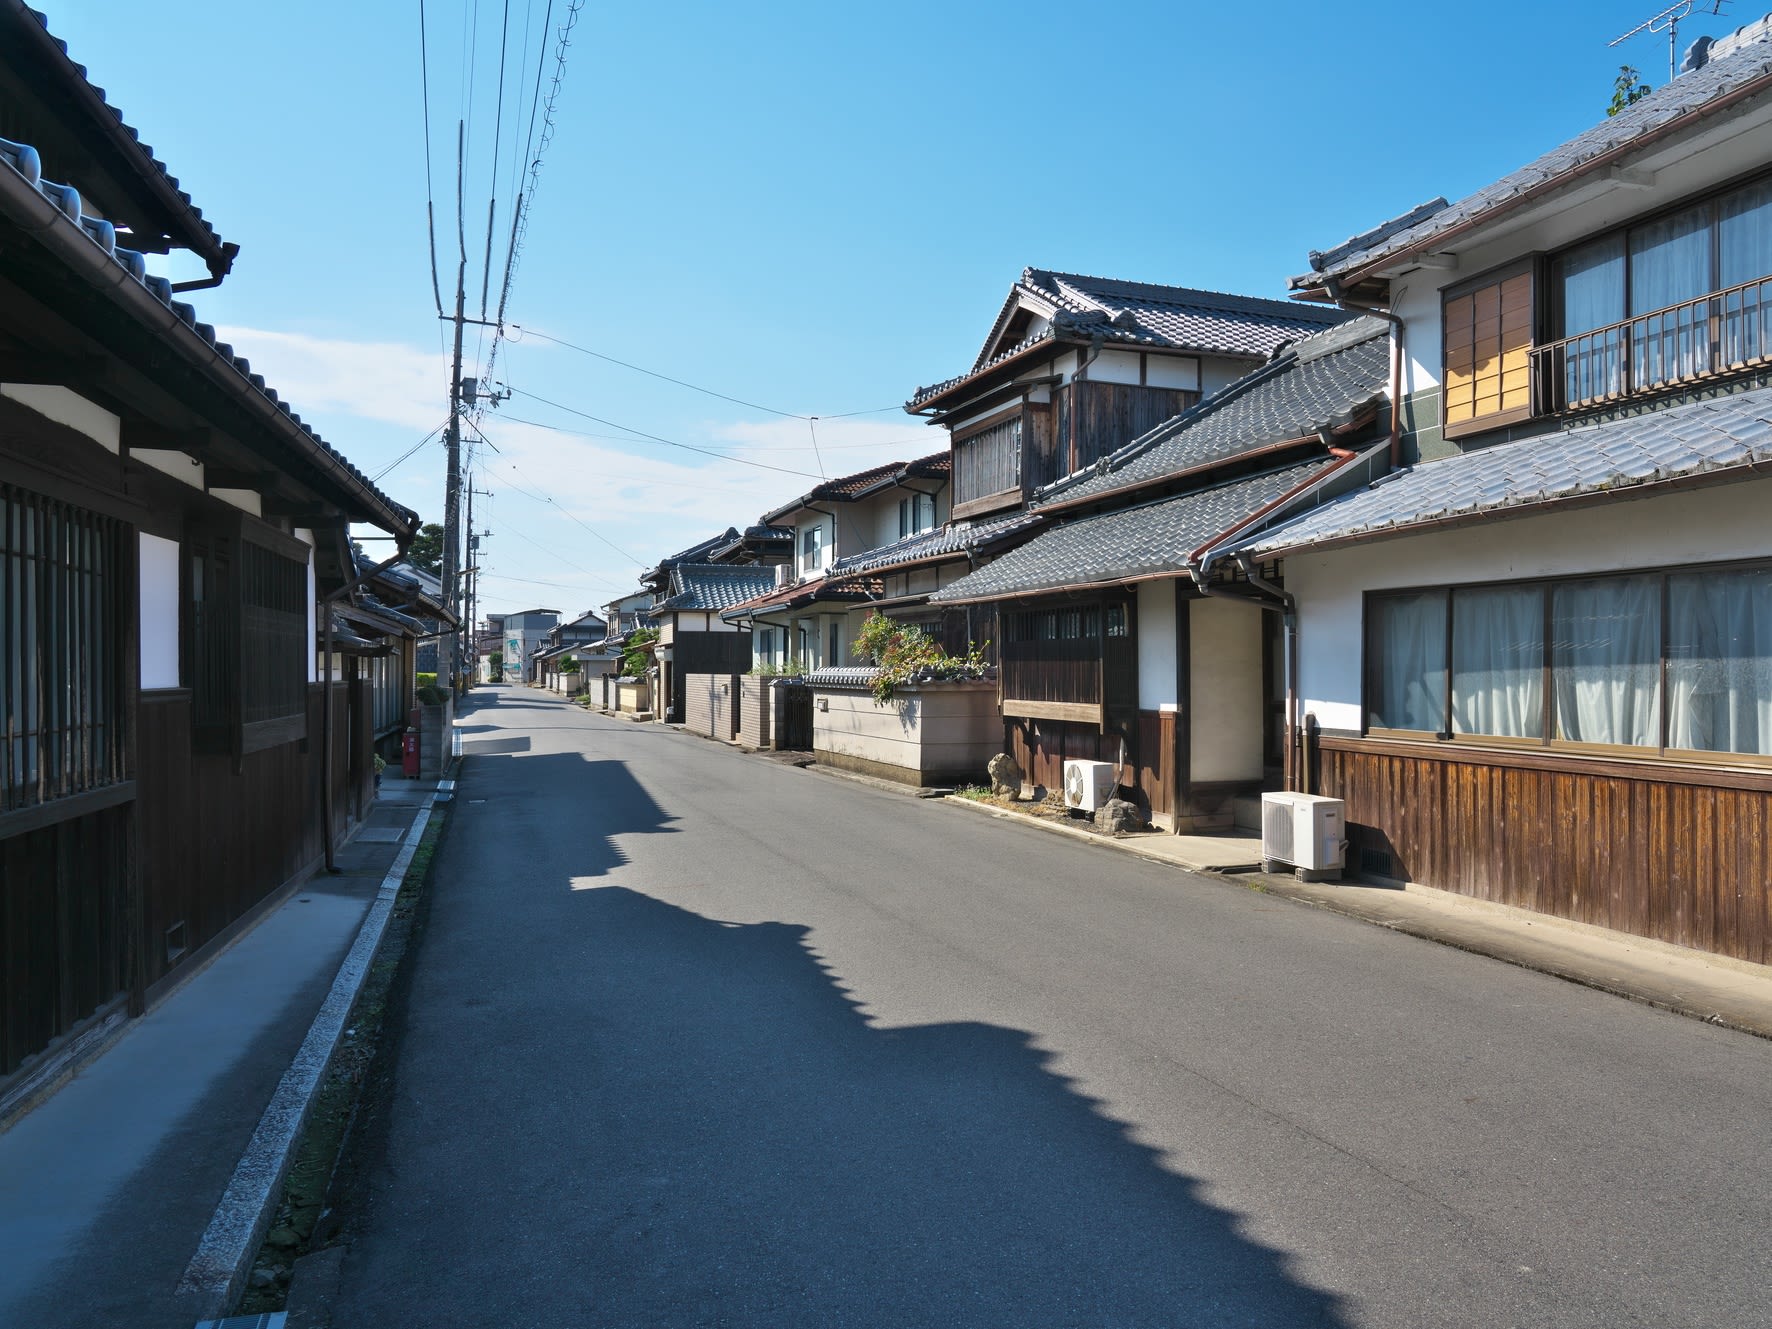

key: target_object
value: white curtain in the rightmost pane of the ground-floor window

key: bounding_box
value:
[1667,569,1772,755]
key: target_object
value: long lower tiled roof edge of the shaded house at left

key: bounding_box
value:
[0,131,418,530]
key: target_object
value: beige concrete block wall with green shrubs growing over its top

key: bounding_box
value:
[812,682,1003,785]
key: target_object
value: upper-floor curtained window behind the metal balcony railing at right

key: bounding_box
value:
[1535,172,1772,409]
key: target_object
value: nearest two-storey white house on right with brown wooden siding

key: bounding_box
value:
[1207,19,1772,964]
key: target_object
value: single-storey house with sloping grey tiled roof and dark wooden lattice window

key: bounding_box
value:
[929,317,1391,831]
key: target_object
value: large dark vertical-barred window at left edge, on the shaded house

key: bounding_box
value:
[0,484,133,812]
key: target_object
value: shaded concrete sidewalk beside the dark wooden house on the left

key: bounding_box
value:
[0,773,450,1329]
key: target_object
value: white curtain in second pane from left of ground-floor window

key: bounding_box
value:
[1451,587,1545,739]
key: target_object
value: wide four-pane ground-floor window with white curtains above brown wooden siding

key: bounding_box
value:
[1366,567,1772,757]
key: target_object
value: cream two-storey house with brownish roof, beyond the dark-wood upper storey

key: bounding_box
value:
[723,452,964,670]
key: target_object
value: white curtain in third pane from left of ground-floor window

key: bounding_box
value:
[1551,578,1660,746]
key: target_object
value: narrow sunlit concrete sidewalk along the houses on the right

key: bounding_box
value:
[941,797,1772,1038]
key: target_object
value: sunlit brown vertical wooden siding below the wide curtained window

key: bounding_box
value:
[1318,737,1772,964]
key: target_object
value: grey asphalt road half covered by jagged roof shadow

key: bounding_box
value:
[335,688,1772,1329]
